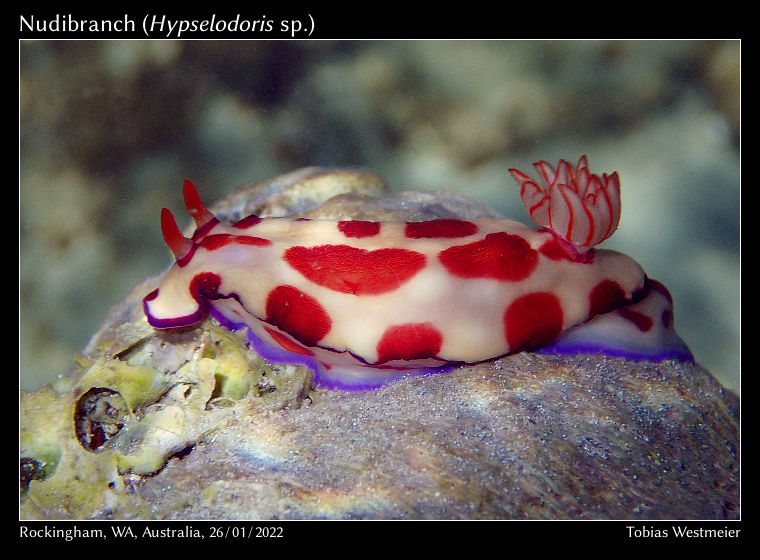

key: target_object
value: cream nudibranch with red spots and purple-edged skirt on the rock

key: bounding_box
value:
[143,156,692,389]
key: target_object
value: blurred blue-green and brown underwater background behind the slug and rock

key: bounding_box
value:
[19,41,740,391]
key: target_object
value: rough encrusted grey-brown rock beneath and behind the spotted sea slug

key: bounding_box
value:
[20,168,739,520]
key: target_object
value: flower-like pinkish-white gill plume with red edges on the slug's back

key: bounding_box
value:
[509,155,620,253]
